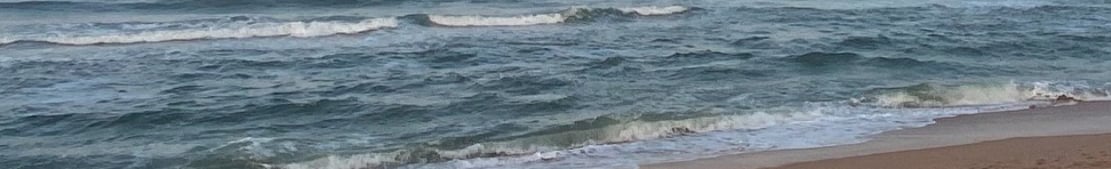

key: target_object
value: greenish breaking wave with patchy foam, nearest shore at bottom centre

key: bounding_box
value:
[274,112,822,169]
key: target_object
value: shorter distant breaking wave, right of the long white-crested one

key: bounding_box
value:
[428,6,690,27]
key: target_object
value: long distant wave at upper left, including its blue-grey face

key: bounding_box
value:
[0,17,398,44]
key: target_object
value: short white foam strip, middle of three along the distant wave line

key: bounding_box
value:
[428,13,567,27]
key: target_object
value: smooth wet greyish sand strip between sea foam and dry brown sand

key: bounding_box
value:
[640,101,1111,169]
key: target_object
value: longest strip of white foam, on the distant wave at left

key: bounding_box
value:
[3,18,398,44]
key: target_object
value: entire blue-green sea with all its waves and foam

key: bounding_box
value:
[0,0,1111,169]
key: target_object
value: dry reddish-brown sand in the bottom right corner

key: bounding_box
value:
[769,135,1111,169]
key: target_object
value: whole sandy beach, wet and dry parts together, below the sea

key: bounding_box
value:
[641,101,1111,169]
